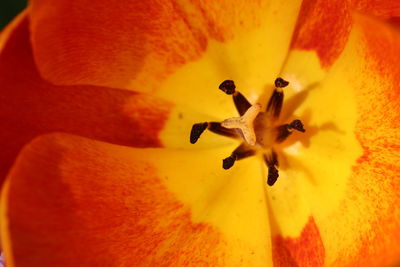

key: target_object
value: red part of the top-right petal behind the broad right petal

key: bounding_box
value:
[291,0,400,68]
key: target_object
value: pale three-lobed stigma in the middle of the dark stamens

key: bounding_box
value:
[221,104,261,145]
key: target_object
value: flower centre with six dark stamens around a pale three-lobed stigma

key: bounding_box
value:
[190,78,305,186]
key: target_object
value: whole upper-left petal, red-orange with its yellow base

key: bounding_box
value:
[31,0,301,109]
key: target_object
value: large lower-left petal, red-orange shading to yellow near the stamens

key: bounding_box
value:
[1,134,272,266]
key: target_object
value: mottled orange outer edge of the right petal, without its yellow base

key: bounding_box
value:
[337,16,400,266]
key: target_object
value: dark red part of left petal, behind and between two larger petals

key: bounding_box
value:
[0,15,172,184]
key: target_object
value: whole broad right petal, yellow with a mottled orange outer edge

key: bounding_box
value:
[269,15,400,266]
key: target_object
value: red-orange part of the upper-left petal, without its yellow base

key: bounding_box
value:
[30,0,270,91]
